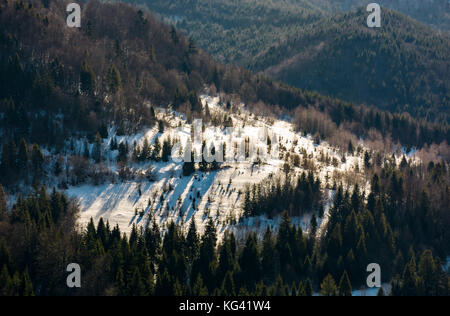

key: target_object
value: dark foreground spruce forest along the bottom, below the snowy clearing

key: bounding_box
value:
[0,183,449,296]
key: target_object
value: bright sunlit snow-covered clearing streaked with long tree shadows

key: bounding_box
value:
[63,96,384,238]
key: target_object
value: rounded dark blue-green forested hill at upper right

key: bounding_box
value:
[251,9,450,123]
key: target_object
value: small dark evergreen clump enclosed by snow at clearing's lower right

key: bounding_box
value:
[243,172,323,218]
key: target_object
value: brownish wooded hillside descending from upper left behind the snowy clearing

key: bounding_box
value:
[0,1,450,155]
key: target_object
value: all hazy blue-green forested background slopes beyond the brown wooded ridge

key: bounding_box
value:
[126,0,450,123]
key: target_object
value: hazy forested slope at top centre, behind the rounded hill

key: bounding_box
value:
[114,0,324,65]
